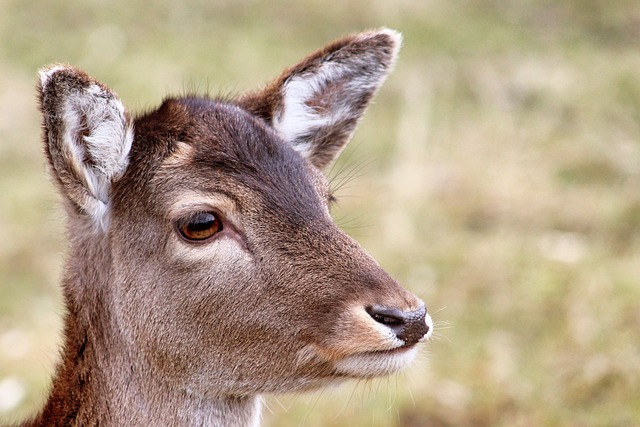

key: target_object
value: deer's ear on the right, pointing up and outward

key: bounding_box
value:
[239,29,402,169]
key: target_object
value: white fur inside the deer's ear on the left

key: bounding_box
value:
[63,84,133,229]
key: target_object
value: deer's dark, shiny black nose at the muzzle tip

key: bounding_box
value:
[366,306,429,345]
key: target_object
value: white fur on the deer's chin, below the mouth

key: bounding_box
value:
[336,346,418,378]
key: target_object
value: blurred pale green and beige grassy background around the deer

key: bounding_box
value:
[0,0,640,426]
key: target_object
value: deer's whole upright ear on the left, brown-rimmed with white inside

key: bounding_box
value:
[38,65,133,229]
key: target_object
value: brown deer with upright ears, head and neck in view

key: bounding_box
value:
[15,28,433,426]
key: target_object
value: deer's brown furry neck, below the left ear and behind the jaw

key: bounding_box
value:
[31,227,261,426]
